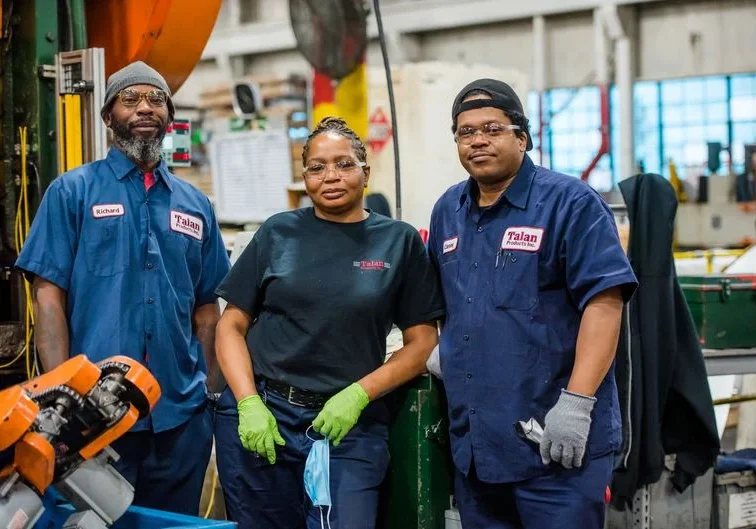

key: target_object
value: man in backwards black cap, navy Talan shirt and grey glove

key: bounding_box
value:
[428,79,637,529]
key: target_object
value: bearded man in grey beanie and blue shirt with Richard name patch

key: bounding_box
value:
[16,62,230,515]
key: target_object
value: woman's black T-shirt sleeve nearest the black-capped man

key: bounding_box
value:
[394,229,446,330]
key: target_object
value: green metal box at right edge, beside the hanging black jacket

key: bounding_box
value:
[678,274,756,349]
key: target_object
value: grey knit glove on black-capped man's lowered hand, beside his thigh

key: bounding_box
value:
[540,389,596,468]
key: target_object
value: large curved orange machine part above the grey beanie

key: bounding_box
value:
[87,0,221,93]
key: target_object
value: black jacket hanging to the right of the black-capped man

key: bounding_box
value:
[612,174,719,508]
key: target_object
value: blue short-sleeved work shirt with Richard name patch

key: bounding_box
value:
[16,148,230,432]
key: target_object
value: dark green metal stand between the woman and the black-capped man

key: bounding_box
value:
[378,375,452,529]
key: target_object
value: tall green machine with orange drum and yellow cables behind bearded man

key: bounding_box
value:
[0,0,221,389]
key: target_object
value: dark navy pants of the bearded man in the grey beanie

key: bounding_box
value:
[111,406,213,516]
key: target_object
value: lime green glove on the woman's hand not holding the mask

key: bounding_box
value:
[236,395,286,465]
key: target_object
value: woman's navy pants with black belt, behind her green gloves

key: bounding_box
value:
[215,383,389,529]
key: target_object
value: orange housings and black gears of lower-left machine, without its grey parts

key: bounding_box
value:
[0,355,161,494]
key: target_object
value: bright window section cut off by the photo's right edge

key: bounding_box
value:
[730,74,756,174]
